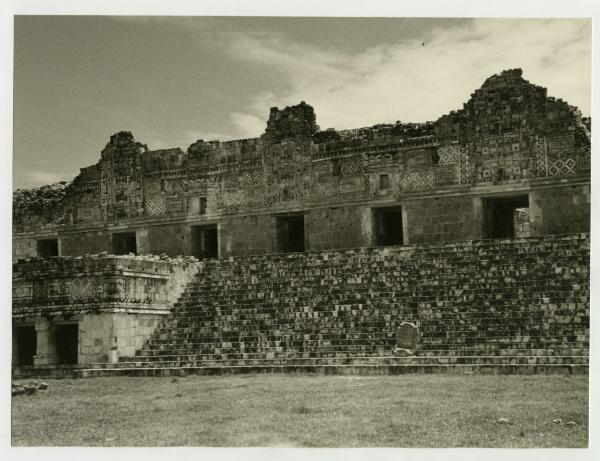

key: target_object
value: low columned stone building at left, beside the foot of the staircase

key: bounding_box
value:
[12,255,201,376]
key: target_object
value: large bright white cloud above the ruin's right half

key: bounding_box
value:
[228,19,591,129]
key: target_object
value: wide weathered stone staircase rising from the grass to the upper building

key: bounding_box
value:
[78,234,589,377]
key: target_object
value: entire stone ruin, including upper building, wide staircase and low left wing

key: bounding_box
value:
[12,69,591,376]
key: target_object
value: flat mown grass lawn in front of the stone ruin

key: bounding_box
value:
[12,375,588,447]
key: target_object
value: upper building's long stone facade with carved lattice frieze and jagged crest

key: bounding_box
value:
[13,69,590,257]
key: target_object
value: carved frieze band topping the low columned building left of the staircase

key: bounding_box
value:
[13,255,197,320]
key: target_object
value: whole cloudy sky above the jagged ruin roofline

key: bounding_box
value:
[13,16,591,188]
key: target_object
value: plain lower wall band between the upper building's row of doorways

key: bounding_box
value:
[13,184,590,260]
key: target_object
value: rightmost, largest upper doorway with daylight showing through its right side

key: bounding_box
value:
[483,195,529,238]
